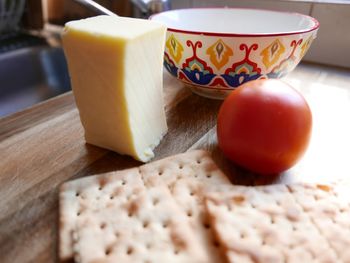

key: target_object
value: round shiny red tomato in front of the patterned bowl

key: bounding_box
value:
[217,79,312,174]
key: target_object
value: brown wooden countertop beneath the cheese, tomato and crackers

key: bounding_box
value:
[0,64,350,263]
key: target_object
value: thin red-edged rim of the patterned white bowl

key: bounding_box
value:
[149,7,320,37]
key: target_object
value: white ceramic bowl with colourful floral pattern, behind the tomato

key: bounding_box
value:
[150,8,319,99]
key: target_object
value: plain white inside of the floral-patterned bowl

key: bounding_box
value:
[152,8,318,35]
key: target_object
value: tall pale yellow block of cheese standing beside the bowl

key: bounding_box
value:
[62,16,167,162]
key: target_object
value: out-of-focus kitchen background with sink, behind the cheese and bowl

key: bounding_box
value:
[0,0,350,117]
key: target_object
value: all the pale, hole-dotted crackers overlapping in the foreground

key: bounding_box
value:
[59,150,350,263]
